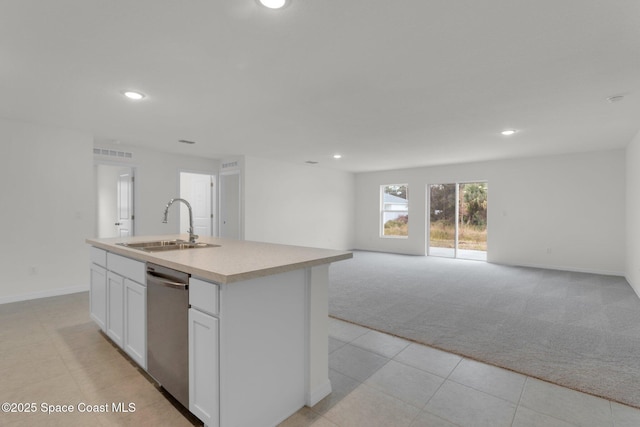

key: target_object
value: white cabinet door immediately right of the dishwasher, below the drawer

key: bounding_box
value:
[189,308,220,427]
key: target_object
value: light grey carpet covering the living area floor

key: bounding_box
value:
[329,252,640,408]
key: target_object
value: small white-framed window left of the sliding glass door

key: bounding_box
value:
[380,184,409,237]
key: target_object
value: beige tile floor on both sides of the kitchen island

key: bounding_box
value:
[0,293,640,427]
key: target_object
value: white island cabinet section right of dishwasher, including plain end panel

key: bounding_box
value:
[189,270,307,427]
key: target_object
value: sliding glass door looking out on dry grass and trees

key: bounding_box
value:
[427,182,488,261]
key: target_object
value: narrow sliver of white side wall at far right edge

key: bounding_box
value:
[625,132,640,296]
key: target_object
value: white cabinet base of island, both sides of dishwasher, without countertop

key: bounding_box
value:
[90,248,316,427]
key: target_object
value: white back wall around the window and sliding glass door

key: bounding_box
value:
[356,150,625,275]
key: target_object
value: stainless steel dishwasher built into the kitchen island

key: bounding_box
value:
[147,263,189,408]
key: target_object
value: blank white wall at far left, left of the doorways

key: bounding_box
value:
[0,119,94,303]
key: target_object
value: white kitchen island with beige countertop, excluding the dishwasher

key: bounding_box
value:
[87,235,352,427]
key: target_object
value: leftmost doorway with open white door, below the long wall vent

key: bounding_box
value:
[94,163,135,238]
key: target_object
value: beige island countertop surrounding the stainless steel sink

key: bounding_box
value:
[87,234,353,284]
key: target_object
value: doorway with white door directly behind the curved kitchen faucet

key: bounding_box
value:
[180,172,218,236]
